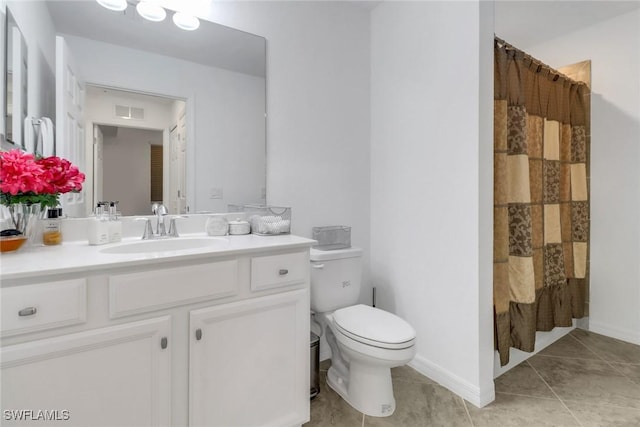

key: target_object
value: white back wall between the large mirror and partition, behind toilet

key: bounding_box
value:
[209,1,371,303]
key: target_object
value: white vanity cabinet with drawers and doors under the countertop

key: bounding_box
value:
[0,236,310,427]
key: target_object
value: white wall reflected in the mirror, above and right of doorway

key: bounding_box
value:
[64,35,265,216]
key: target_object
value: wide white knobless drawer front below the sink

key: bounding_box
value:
[109,259,238,319]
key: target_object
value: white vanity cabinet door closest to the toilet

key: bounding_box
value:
[189,289,309,427]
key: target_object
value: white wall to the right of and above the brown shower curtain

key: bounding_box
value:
[510,9,640,344]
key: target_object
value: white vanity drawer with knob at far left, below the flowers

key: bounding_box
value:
[0,279,87,336]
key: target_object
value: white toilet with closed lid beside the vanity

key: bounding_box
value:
[311,248,416,417]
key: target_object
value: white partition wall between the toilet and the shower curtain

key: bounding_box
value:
[371,2,494,406]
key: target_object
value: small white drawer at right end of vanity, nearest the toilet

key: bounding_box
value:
[251,252,309,291]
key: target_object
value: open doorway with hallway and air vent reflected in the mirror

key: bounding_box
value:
[85,86,187,215]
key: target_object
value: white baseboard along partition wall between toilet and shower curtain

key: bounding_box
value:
[409,355,496,408]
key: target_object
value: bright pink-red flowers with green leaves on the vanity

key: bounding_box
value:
[0,149,85,209]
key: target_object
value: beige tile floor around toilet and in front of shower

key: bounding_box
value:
[305,329,640,427]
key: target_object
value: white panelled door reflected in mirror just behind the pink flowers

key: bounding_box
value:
[56,36,86,217]
